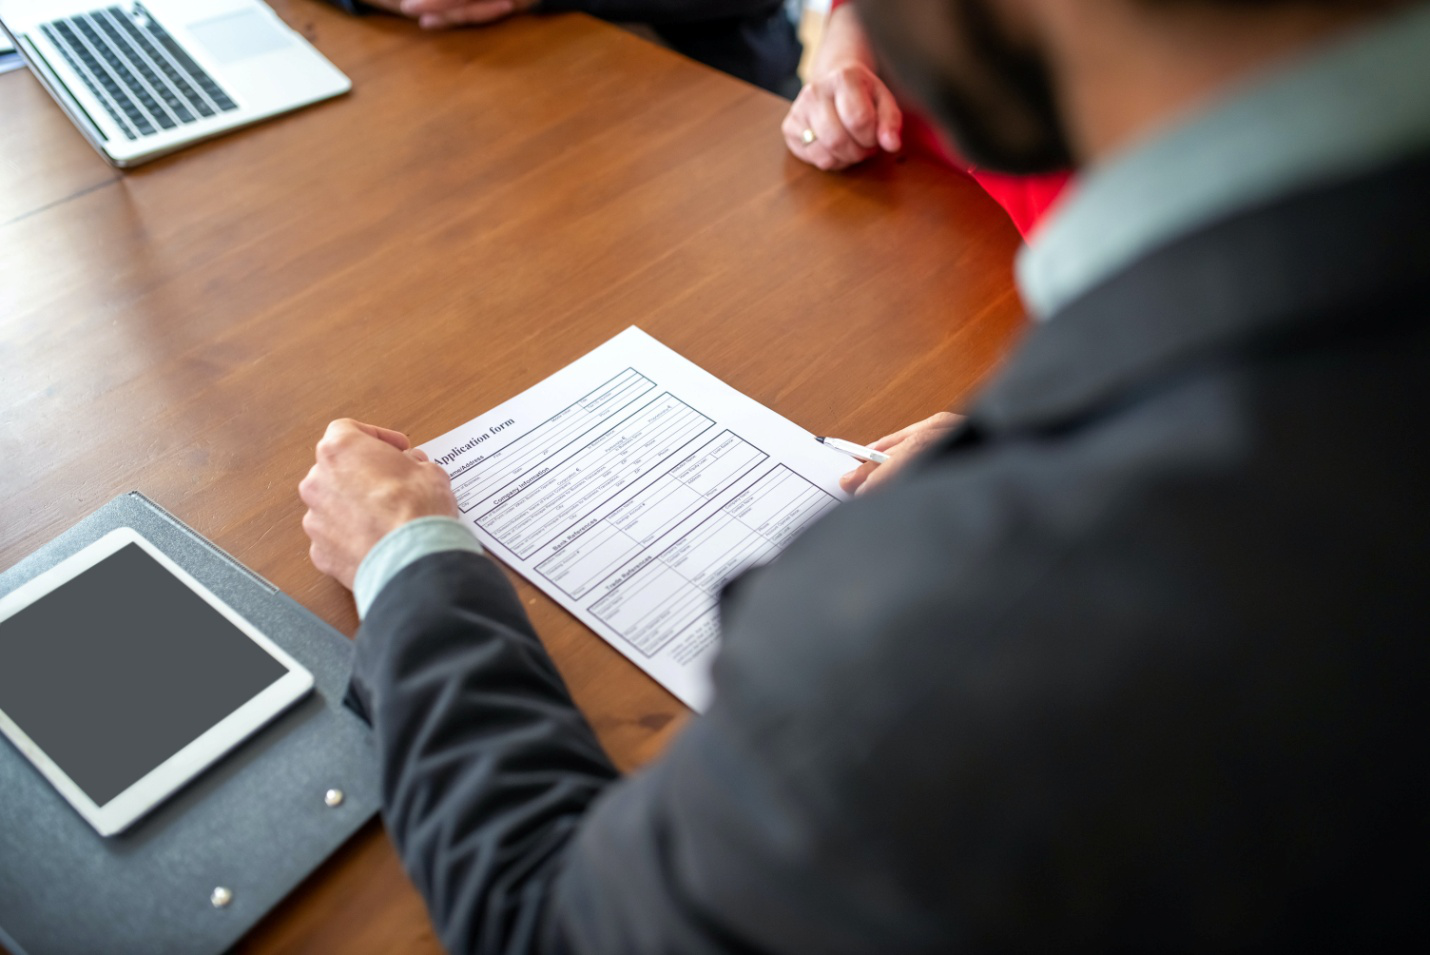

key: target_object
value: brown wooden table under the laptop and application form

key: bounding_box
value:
[0,0,1021,955]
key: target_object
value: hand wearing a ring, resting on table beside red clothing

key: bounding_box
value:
[779,4,904,170]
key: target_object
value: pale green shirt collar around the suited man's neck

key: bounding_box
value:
[1017,4,1430,319]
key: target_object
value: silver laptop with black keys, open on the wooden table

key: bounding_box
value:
[0,0,352,167]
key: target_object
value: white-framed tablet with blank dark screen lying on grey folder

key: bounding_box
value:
[0,528,313,836]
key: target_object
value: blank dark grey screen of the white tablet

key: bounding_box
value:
[0,543,289,806]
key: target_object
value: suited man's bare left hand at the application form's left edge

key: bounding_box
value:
[297,417,459,590]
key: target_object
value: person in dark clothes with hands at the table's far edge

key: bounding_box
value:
[321,0,804,99]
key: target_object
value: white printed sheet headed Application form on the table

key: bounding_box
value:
[422,327,852,711]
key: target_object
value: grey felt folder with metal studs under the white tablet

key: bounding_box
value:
[0,493,379,955]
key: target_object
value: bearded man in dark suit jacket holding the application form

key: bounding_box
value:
[300,0,1430,955]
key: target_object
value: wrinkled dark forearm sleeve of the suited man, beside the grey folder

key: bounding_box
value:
[352,552,618,952]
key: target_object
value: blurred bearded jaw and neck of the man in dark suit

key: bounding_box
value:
[861,0,1410,173]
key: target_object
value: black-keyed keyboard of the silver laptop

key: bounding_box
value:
[40,3,239,139]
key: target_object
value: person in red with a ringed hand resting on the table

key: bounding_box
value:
[781,0,1068,237]
